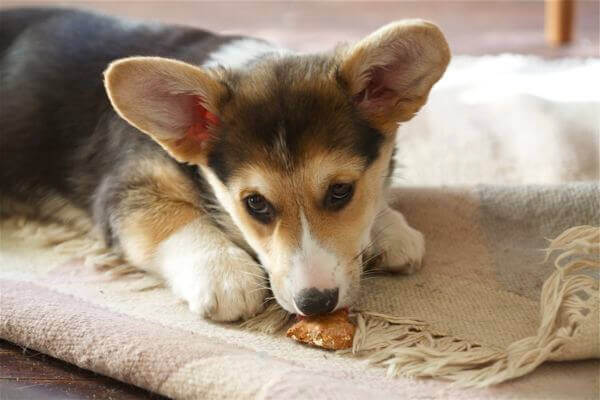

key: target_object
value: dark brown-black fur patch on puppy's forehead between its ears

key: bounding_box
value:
[209,56,384,182]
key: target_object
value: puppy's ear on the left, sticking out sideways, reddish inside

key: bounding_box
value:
[104,57,227,164]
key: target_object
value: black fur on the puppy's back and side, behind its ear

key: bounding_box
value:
[0,9,239,239]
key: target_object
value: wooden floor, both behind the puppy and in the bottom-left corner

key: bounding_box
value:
[0,1,600,400]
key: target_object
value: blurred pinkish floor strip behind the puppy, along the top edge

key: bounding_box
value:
[0,0,600,57]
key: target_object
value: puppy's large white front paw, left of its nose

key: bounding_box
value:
[171,247,267,321]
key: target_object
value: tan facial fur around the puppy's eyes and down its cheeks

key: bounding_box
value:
[221,142,393,303]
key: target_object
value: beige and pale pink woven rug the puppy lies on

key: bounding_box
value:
[0,183,600,398]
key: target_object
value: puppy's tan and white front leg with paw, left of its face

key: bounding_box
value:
[97,161,266,321]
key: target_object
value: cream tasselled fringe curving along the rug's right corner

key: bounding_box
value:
[352,226,600,387]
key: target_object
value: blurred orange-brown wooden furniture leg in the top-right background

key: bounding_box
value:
[544,0,574,46]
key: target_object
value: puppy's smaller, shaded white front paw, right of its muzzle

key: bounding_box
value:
[371,206,425,274]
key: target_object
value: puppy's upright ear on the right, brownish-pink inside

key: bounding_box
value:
[340,20,450,133]
